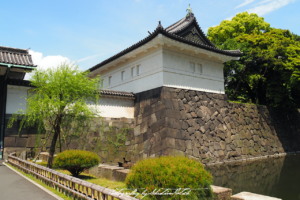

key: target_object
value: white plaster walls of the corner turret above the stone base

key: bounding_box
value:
[101,47,224,94]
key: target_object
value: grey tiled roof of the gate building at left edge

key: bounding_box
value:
[0,46,36,67]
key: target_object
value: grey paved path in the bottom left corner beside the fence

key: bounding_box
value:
[0,160,56,200]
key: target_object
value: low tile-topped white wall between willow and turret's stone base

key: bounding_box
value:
[91,96,134,118]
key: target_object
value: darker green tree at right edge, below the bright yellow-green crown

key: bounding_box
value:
[236,28,300,107]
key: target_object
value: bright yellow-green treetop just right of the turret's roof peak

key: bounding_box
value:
[207,12,270,47]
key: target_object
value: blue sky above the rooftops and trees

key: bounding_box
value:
[0,0,300,74]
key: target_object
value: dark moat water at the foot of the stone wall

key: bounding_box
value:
[207,155,300,200]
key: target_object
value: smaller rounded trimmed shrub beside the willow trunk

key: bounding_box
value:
[53,150,100,177]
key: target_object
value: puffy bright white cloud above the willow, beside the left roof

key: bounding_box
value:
[24,50,71,80]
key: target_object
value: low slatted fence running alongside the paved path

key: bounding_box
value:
[8,153,137,200]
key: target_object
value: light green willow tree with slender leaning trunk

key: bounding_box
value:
[8,63,102,168]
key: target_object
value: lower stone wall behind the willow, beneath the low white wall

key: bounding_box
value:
[4,116,134,164]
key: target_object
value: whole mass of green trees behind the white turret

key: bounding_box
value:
[208,12,300,107]
